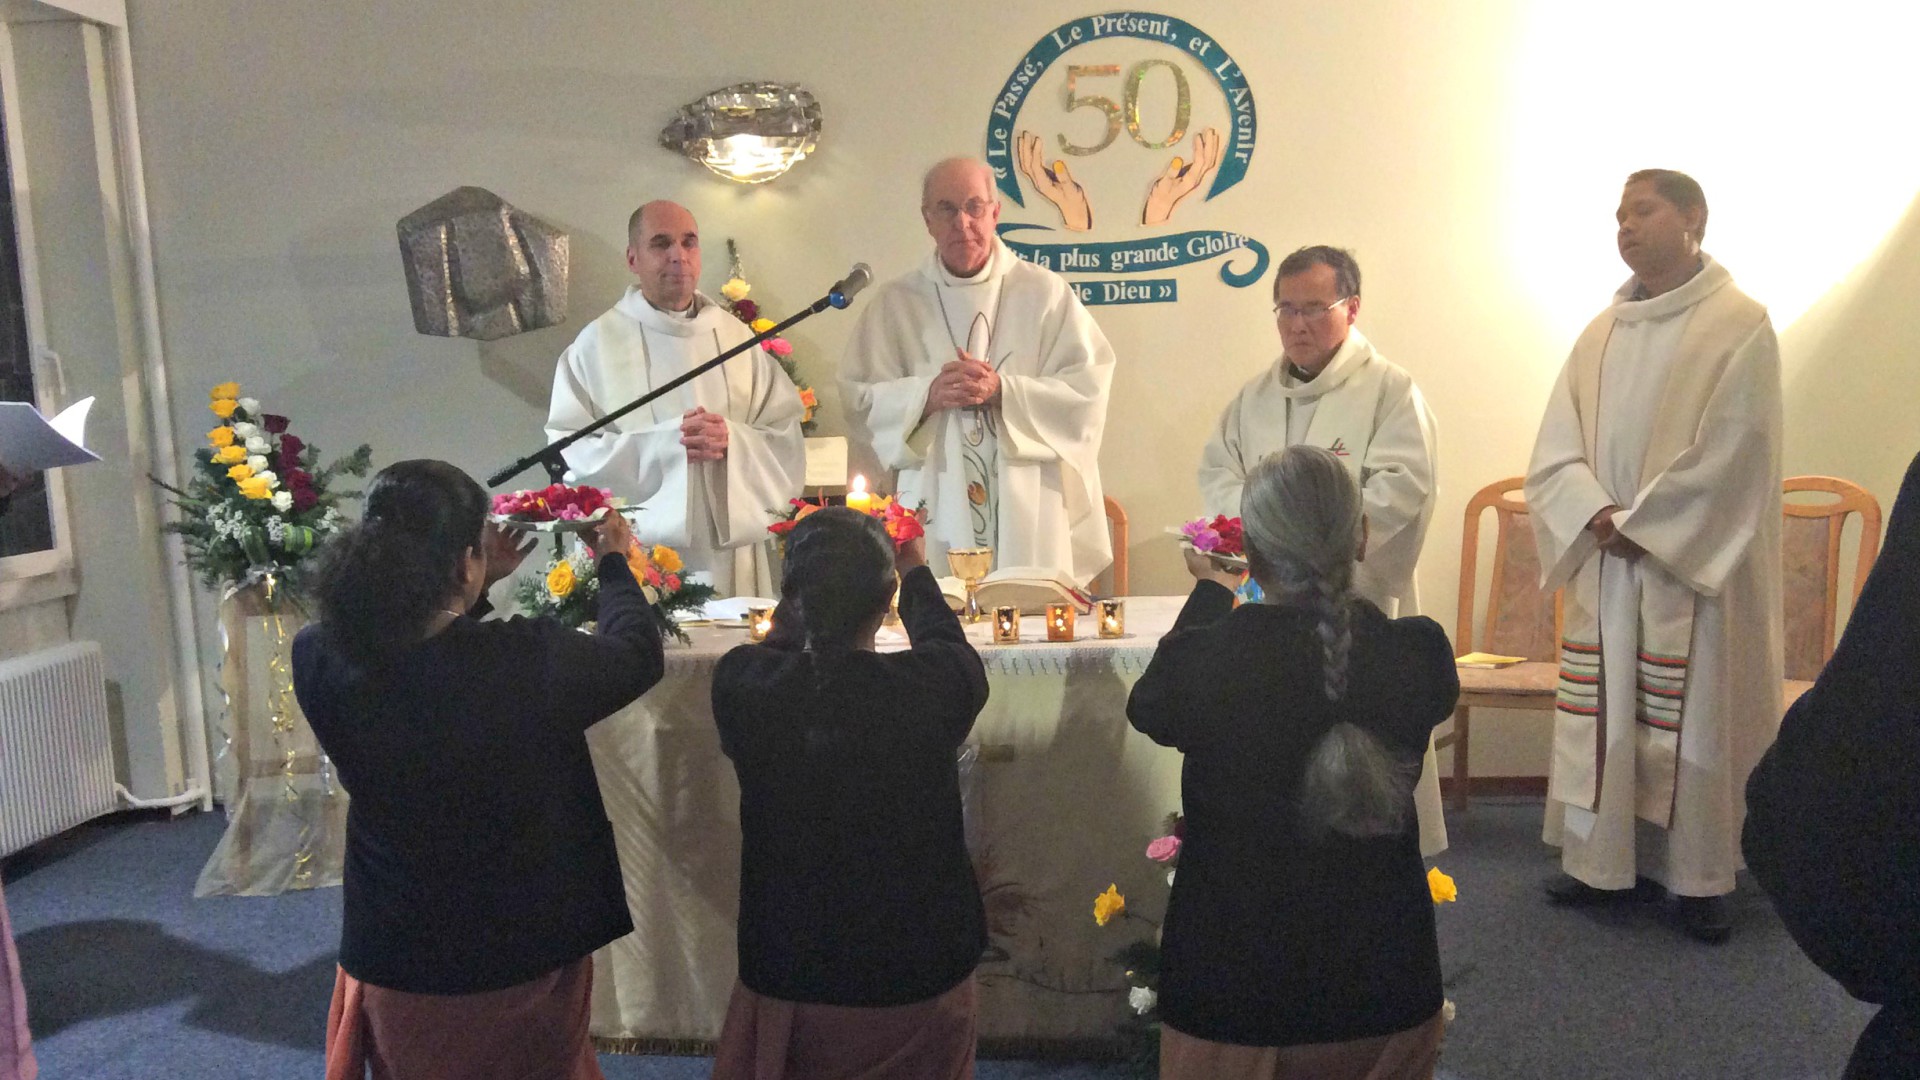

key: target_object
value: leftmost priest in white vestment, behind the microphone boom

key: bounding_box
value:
[547,202,806,598]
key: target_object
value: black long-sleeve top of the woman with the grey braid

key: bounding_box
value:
[1127,582,1459,1045]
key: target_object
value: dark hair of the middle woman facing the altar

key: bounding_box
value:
[780,505,895,661]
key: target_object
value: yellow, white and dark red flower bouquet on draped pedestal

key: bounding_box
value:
[148,382,372,596]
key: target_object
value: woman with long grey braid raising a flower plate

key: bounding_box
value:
[1127,446,1459,1080]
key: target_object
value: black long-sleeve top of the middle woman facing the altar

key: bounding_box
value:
[712,567,987,1005]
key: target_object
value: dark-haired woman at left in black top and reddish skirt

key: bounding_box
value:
[294,461,662,1080]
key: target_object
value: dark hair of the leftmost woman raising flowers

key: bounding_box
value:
[313,457,488,663]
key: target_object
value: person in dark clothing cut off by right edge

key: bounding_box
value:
[1740,447,1920,1080]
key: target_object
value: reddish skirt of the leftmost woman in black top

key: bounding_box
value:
[326,957,607,1080]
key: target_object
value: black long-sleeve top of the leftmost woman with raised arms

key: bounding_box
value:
[294,555,664,994]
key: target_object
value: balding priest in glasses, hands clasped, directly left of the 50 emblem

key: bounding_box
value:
[839,160,1114,586]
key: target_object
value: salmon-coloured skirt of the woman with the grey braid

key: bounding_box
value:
[1160,1013,1446,1080]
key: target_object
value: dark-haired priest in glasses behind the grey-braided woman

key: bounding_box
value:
[1200,244,1448,855]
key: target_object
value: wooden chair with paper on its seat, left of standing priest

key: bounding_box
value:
[1434,477,1561,811]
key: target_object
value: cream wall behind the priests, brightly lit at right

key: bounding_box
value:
[132,0,1920,774]
